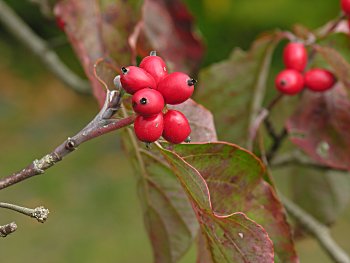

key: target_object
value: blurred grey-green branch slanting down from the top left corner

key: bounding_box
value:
[0,0,91,94]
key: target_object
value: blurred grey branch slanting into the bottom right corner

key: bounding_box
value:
[279,193,350,263]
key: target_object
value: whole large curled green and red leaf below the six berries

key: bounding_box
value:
[162,142,298,262]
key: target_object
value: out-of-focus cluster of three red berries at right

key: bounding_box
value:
[275,42,334,95]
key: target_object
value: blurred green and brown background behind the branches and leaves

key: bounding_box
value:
[0,0,350,263]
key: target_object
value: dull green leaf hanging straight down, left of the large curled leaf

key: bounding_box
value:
[123,134,198,263]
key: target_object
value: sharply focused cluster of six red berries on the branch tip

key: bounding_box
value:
[120,51,196,143]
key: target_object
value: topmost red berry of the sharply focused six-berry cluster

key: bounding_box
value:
[140,51,168,84]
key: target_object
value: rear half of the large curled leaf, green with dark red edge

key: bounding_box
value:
[165,143,298,262]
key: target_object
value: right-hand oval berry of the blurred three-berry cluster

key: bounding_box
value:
[304,68,335,91]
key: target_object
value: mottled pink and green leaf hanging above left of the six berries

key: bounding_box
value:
[54,0,141,105]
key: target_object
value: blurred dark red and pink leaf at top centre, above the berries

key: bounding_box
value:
[129,0,204,74]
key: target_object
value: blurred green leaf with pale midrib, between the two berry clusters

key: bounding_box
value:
[196,32,282,146]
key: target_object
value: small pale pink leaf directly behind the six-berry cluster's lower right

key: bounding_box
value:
[168,99,217,142]
